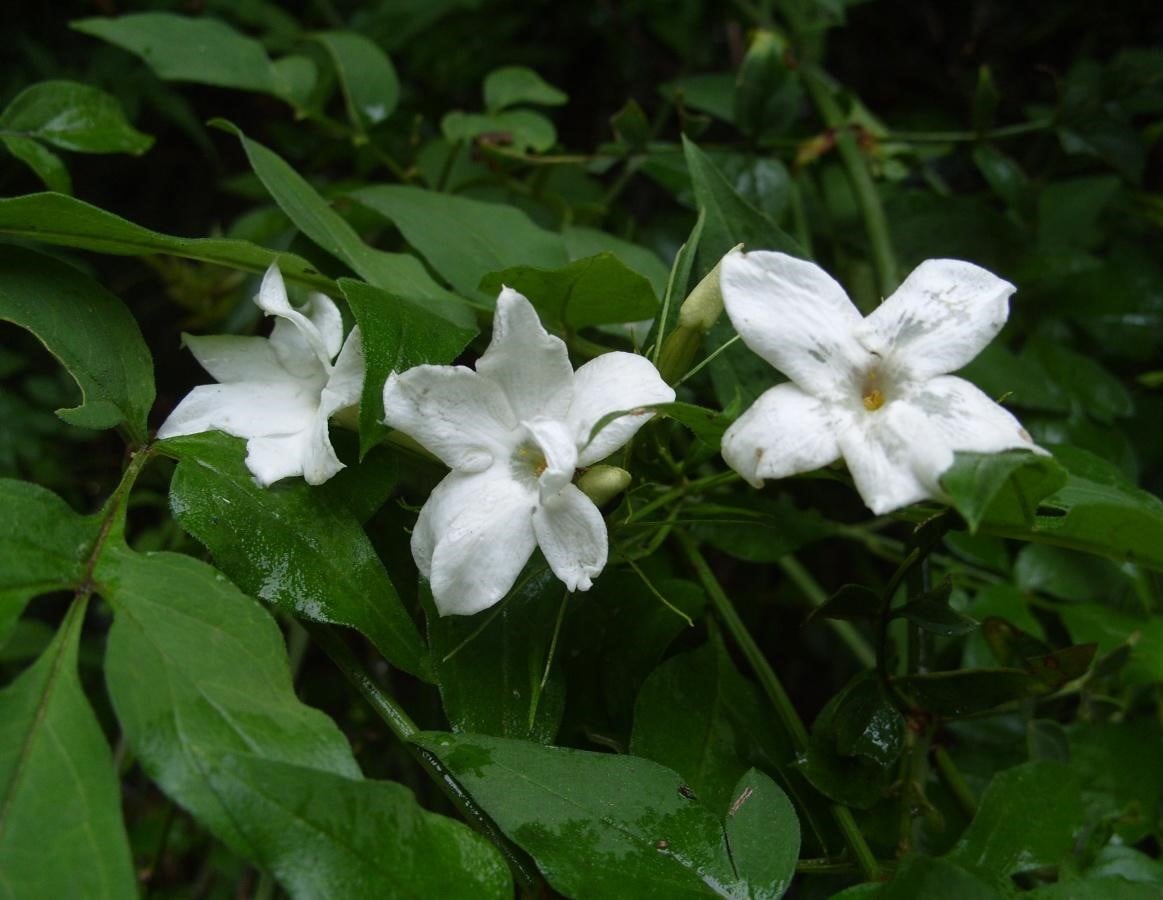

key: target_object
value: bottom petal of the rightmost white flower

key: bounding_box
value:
[839,400,952,515]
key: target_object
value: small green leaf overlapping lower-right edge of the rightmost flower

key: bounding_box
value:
[941,450,1066,534]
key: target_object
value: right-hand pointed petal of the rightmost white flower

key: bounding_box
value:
[905,376,1046,453]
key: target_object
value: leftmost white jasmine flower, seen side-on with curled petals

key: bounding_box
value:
[157,263,364,487]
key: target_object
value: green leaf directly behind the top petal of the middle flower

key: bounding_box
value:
[480,253,658,328]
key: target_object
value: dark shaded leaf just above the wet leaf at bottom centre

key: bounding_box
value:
[630,638,794,812]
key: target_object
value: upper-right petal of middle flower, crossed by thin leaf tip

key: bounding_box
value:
[565,351,675,465]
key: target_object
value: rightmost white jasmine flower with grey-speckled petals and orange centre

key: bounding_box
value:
[722,251,1046,514]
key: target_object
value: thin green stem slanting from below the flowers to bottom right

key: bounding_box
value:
[675,531,880,880]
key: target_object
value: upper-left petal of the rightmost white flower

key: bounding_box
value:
[720,250,872,399]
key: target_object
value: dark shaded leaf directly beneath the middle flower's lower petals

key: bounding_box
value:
[428,569,569,744]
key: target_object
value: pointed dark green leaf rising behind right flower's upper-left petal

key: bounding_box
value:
[683,137,807,277]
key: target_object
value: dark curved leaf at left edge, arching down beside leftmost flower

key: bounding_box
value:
[0,247,154,443]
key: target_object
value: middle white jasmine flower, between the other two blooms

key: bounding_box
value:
[384,287,675,615]
